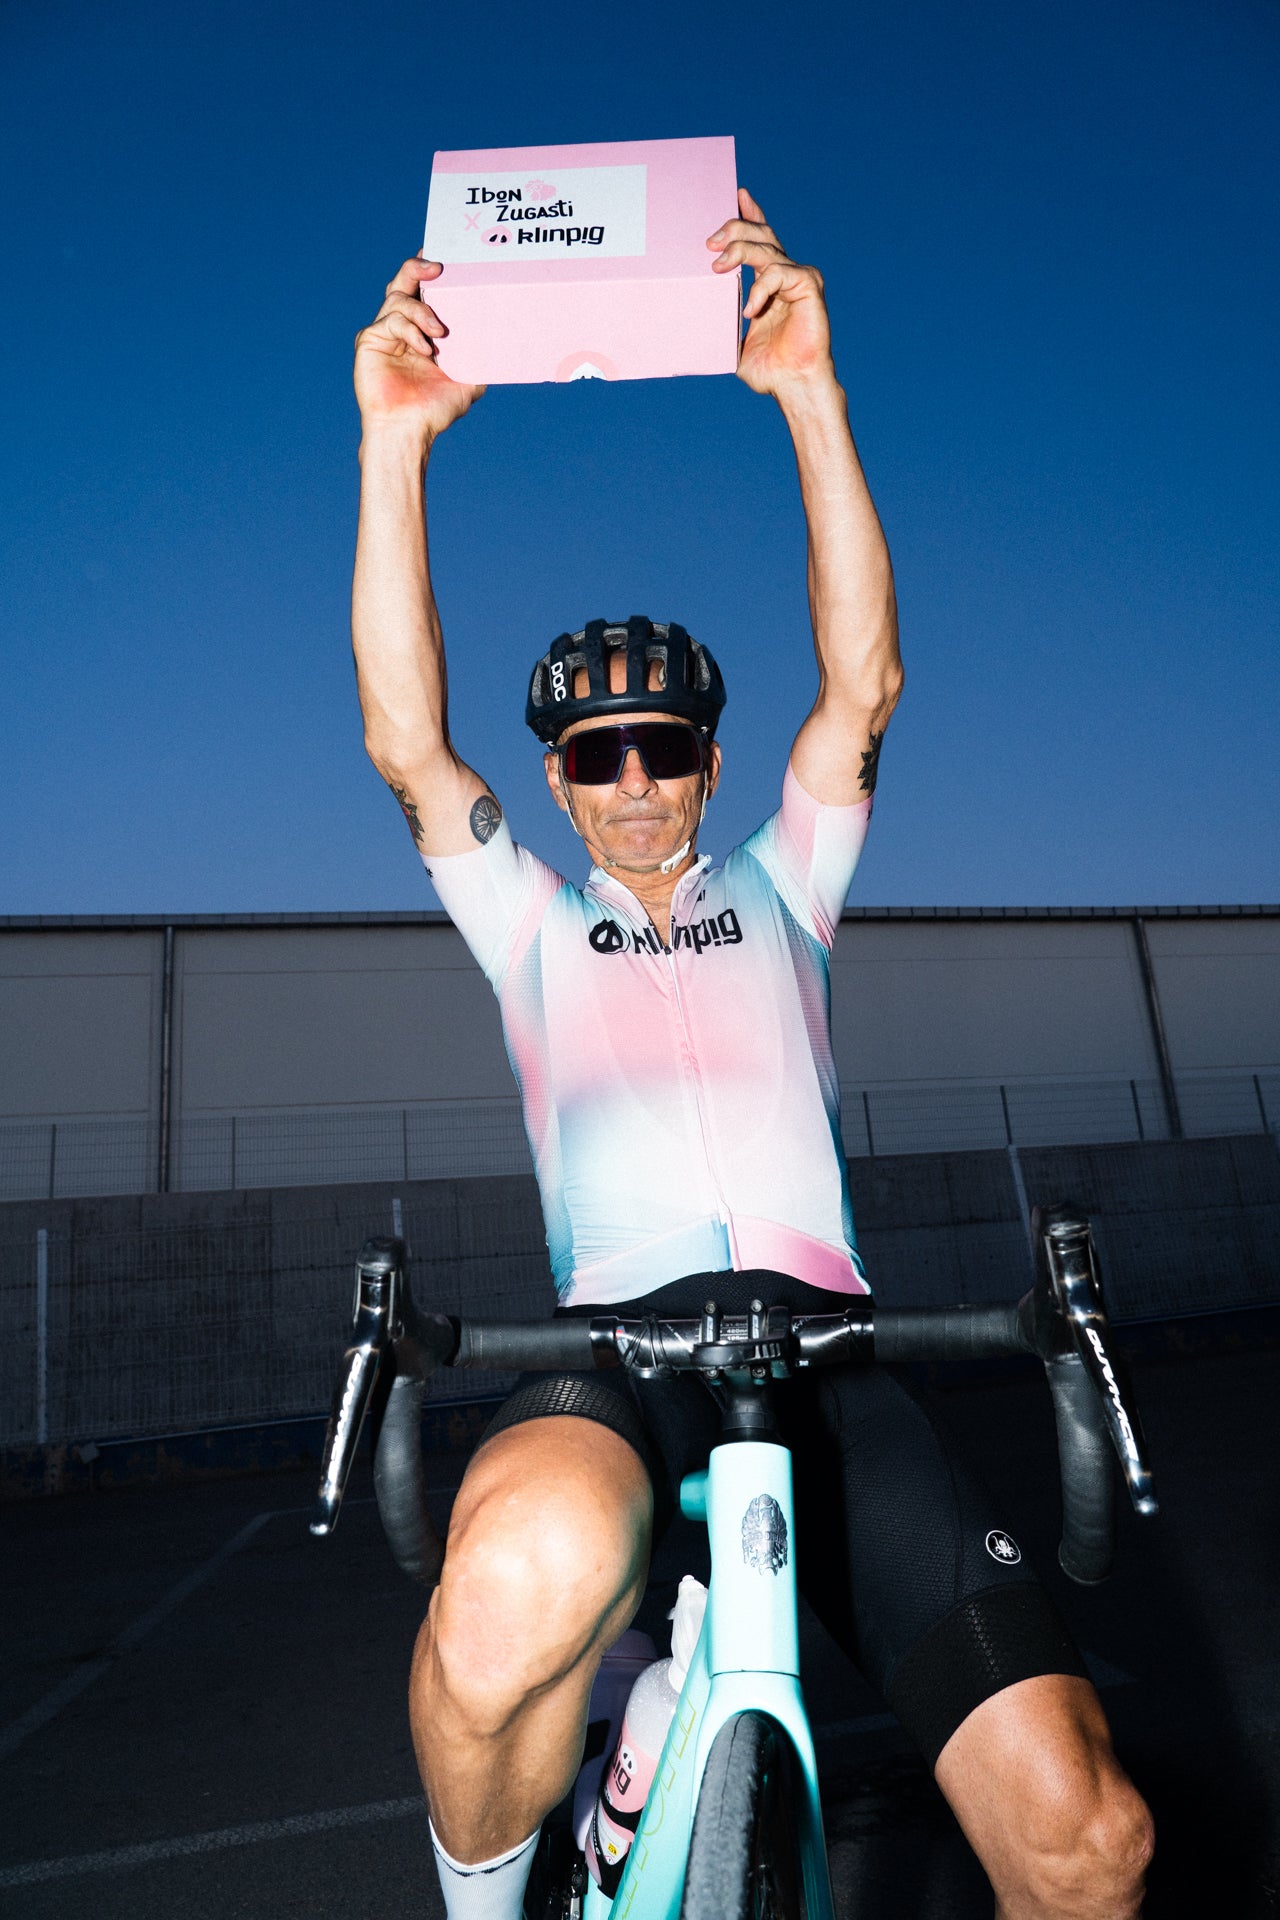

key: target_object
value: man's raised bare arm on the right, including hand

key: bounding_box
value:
[706,190,902,806]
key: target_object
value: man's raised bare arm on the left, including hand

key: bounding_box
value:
[351,259,501,854]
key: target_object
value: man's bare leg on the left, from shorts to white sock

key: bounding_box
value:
[409,1417,652,1862]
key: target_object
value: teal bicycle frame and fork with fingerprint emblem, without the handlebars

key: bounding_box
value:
[583,1440,833,1920]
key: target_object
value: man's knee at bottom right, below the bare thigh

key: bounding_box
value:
[1025,1770,1155,1920]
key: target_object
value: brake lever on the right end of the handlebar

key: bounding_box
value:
[1036,1208,1159,1515]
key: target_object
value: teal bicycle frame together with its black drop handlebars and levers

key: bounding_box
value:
[311,1202,1157,1920]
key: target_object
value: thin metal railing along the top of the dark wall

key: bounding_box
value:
[0,1068,1280,1200]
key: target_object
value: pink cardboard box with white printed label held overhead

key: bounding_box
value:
[422,138,743,382]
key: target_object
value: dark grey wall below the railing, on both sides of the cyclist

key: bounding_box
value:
[0,1133,1280,1446]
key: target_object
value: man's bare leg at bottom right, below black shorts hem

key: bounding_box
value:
[936,1674,1153,1920]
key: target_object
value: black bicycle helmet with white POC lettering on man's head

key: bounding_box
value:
[524,612,725,747]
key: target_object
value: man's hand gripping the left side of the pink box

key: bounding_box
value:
[355,259,484,440]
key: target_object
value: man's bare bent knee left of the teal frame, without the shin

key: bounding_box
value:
[416,1421,649,1732]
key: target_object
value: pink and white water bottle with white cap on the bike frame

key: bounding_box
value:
[585,1574,706,1899]
